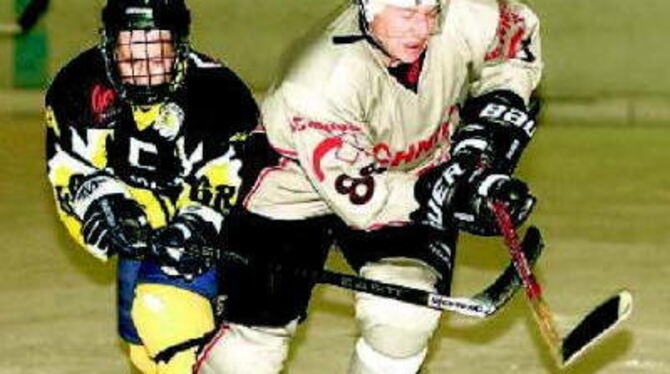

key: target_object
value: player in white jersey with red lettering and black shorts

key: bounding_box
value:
[197,0,542,374]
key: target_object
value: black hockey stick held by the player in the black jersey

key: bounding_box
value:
[220,227,544,318]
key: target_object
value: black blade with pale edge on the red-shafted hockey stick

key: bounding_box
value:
[561,290,633,367]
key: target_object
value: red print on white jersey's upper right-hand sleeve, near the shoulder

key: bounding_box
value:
[485,5,526,61]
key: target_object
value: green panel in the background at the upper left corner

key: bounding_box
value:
[13,0,48,89]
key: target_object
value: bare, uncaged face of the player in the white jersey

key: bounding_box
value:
[370,5,440,63]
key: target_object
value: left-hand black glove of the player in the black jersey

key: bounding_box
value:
[81,194,151,258]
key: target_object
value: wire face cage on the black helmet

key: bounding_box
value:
[102,30,190,105]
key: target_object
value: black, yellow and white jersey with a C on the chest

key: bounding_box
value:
[46,48,258,259]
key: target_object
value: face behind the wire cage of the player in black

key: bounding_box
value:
[116,30,175,86]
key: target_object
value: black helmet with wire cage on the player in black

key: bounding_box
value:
[101,0,191,105]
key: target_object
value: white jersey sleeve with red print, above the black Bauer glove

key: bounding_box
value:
[470,1,543,103]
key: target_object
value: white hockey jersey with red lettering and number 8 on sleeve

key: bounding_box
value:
[245,0,542,230]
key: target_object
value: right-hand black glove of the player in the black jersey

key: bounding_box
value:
[151,214,219,280]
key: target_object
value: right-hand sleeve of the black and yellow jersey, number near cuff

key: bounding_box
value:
[177,60,259,231]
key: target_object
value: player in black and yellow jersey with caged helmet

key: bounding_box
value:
[46,0,258,374]
